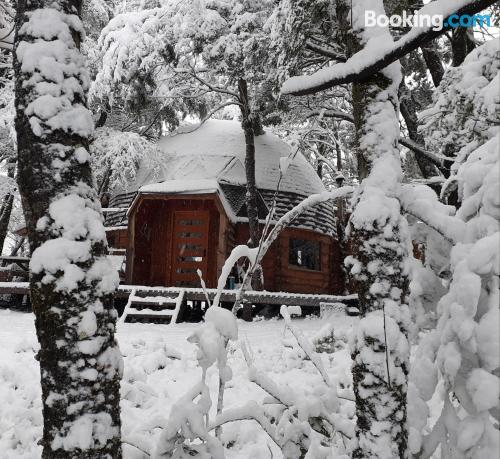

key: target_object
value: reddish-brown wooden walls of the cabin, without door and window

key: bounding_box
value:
[108,187,344,294]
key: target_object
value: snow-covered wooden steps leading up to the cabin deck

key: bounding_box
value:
[119,288,185,324]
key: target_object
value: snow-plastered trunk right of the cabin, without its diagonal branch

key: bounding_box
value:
[346,0,409,459]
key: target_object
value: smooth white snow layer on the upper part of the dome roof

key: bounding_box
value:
[135,120,325,195]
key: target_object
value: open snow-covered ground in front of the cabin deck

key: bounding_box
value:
[0,310,356,459]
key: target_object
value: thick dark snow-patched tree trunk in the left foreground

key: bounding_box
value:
[14,0,122,459]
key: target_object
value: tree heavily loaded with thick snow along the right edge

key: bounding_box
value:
[410,40,500,458]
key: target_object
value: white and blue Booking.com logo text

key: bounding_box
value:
[365,10,491,30]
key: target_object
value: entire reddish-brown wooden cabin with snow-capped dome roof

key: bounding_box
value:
[106,120,344,294]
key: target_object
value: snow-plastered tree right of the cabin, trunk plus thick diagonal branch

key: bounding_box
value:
[283,0,496,457]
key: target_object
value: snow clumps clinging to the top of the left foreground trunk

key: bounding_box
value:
[16,8,94,137]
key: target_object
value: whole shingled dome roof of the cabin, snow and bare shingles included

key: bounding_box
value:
[106,120,336,235]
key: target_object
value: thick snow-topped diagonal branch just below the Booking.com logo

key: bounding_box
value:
[281,0,495,96]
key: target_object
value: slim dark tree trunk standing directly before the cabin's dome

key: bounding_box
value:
[238,78,263,290]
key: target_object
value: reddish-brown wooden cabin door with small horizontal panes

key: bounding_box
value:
[170,210,210,287]
